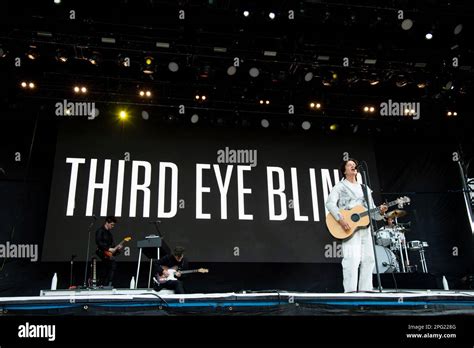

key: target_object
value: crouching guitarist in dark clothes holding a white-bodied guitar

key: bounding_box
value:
[154,246,188,294]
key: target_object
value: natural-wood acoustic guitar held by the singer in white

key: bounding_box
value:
[326,197,410,239]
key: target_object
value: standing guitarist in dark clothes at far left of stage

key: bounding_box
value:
[95,216,122,286]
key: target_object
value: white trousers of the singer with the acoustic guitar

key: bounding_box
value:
[342,228,375,292]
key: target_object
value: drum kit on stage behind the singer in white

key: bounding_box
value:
[374,209,428,273]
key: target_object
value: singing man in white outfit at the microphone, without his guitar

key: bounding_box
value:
[326,158,388,292]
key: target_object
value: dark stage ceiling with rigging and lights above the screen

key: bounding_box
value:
[0,0,474,136]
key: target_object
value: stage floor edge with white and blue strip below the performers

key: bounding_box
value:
[0,289,474,316]
